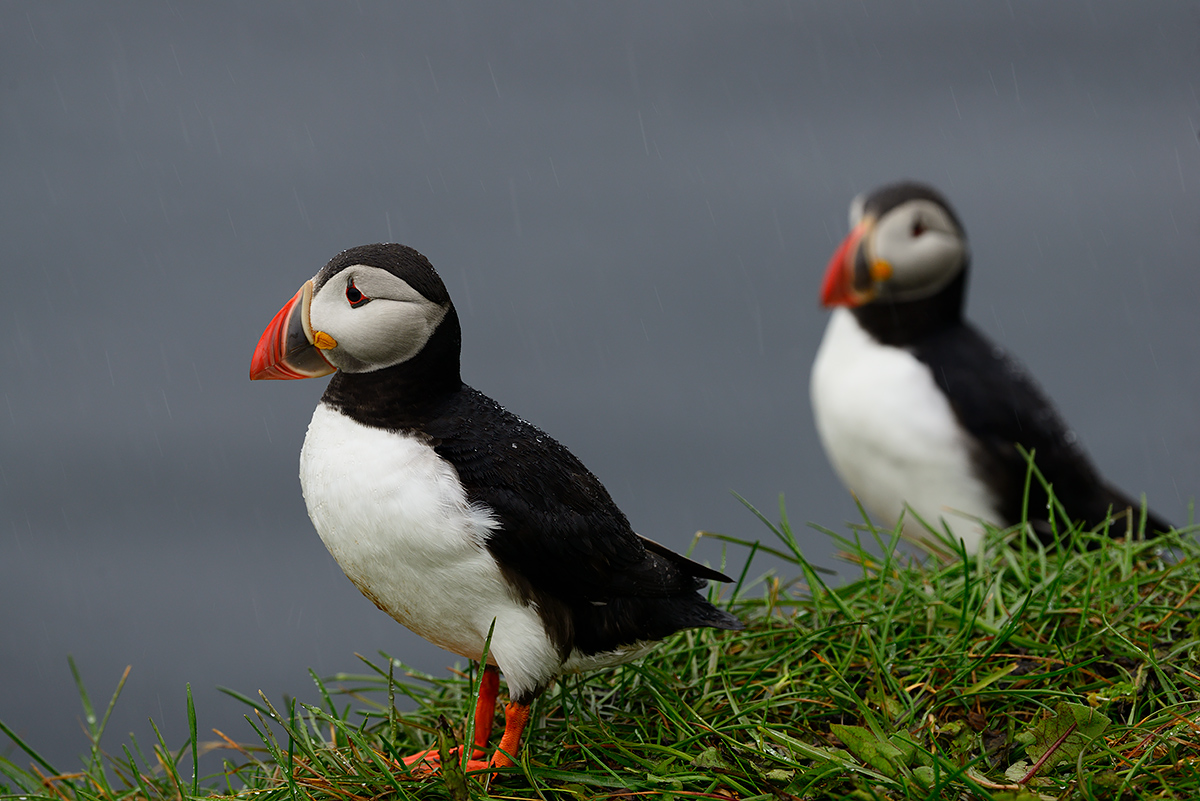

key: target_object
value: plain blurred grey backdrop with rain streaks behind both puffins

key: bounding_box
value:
[0,0,1200,769]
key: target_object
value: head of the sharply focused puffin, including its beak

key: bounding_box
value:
[250,243,458,380]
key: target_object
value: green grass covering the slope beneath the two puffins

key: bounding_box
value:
[0,501,1200,801]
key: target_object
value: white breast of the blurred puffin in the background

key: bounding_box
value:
[811,308,1001,552]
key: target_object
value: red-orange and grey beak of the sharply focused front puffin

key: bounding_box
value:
[250,281,337,381]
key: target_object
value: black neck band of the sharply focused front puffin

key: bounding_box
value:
[320,306,462,430]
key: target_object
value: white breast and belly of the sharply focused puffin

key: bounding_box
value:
[300,403,562,694]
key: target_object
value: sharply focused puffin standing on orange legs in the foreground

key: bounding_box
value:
[250,243,743,771]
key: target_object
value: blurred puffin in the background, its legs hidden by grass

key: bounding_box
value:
[810,182,1170,553]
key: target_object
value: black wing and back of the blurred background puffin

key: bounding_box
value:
[912,324,1170,541]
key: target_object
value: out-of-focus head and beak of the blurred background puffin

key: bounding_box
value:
[821,183,970,308]
